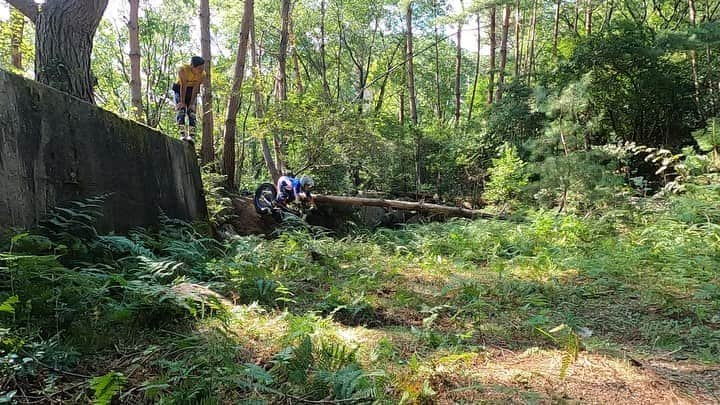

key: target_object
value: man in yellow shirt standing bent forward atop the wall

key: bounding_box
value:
[173,56,205,142]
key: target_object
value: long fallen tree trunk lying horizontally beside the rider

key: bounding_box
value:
[315,195,496,218]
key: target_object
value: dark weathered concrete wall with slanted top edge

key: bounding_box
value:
[0,70,207,232]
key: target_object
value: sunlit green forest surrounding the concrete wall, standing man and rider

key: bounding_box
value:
[0,0,720,404]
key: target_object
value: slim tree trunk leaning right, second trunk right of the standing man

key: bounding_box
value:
[223,0,255,189]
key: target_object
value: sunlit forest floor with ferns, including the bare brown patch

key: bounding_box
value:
[4,187,720,404]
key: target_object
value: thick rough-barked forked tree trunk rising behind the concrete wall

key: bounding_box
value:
[8,0,108,103]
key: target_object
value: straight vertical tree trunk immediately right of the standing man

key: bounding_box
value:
[200,0,215,165]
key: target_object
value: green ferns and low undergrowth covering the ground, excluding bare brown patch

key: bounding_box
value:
[0,184,720,404]
